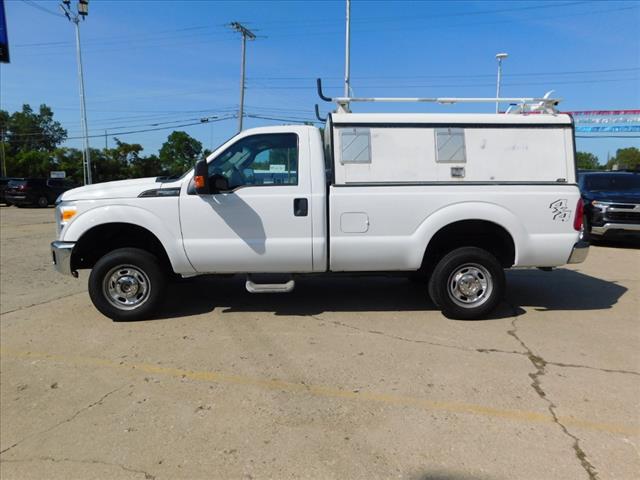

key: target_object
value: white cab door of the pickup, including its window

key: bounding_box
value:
[180,130,312,273]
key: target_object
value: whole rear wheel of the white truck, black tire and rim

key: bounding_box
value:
[429,247,505,320]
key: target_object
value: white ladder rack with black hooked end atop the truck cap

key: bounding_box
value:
[316,78,562,113]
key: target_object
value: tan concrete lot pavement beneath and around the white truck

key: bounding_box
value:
[0,207,640,480]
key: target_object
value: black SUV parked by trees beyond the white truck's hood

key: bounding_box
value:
[5,178,77,208]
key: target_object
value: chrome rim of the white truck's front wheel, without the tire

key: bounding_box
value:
[103,265,151,310]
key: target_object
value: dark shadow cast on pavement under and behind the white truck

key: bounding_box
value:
[155,269,627,320]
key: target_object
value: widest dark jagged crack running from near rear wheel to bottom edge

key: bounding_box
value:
[507,305,598,480]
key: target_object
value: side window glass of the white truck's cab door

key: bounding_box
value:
[209,133,298,189]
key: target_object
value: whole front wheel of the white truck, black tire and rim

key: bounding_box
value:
[89,248,167,322]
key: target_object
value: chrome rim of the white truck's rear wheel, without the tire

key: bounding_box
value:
[447,263,493,308]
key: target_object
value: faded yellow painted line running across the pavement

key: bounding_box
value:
[0,349,640,435]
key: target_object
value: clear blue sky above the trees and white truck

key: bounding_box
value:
[0,0,640,162]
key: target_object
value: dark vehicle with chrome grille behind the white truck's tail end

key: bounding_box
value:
[579,172,640,239]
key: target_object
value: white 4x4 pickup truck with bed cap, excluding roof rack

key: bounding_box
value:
[52,93,588,320]
